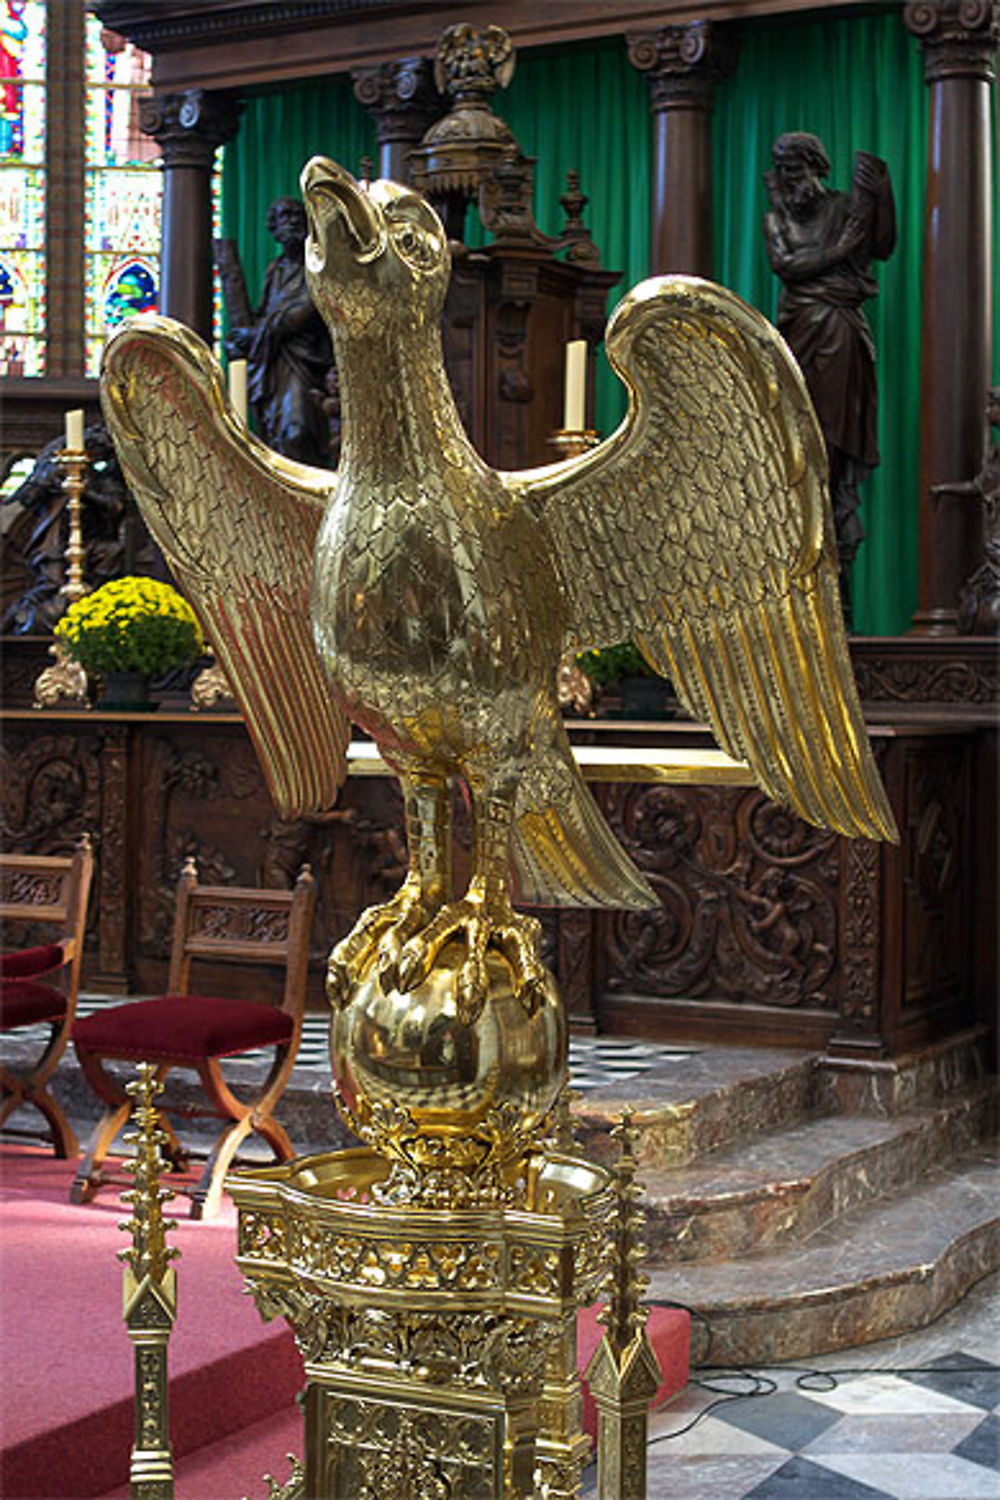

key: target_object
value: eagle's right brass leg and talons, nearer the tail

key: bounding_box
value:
[399,786,546,1020]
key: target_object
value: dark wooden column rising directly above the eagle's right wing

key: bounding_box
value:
[628,21,735,276]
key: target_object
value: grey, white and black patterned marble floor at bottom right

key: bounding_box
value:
[585,1275,1000,1500]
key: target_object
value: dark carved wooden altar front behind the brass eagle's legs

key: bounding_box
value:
[0,713,996,1053]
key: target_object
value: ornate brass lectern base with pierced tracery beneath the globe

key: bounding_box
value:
[228,1148,616,1500]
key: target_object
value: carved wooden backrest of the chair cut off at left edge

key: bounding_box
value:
[0,834,94,999]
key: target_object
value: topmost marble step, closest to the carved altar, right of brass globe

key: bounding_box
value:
[573,1047,834,1170]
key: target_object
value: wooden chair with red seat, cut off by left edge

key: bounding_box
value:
[0,834,94,1158]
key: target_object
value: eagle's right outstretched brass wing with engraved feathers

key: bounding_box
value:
[505,276,897,839]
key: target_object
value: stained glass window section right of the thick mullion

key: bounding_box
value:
[84,15,162,375]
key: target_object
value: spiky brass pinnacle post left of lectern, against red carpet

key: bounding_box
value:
[118,1062,180,1500]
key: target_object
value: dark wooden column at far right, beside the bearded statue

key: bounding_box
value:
[904,0,1000,635]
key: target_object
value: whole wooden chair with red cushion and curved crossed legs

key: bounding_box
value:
[70,860,316,1218]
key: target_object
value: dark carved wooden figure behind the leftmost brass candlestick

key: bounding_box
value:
[0,422,156,635]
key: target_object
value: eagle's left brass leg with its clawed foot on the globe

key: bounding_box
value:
[327,771,451,1004]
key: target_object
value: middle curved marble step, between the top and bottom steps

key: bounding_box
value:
[642,1085,996,1265]
